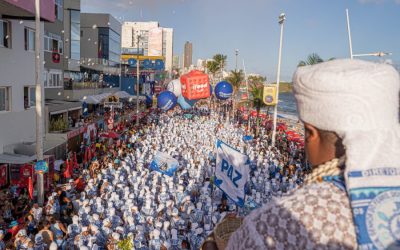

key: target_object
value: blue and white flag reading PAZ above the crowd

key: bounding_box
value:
[214,140,250,207]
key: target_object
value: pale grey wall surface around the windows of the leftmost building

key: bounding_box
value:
[0,20,44,153]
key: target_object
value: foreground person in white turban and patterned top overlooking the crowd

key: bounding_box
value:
[227,59,400,249]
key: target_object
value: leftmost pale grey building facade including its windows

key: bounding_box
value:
[0,18,44,154]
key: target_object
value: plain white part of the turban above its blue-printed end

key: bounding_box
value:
[293,59,400,188]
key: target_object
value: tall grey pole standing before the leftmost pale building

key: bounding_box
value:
[35,0,44,206]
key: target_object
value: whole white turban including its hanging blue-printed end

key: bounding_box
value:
[293,59,400,249]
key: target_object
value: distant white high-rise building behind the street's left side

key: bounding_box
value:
[121,22,174,72]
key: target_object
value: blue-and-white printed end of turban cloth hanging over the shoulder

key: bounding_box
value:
[347,167,400,249]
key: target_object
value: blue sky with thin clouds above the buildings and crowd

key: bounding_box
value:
[81,0,400,81]
